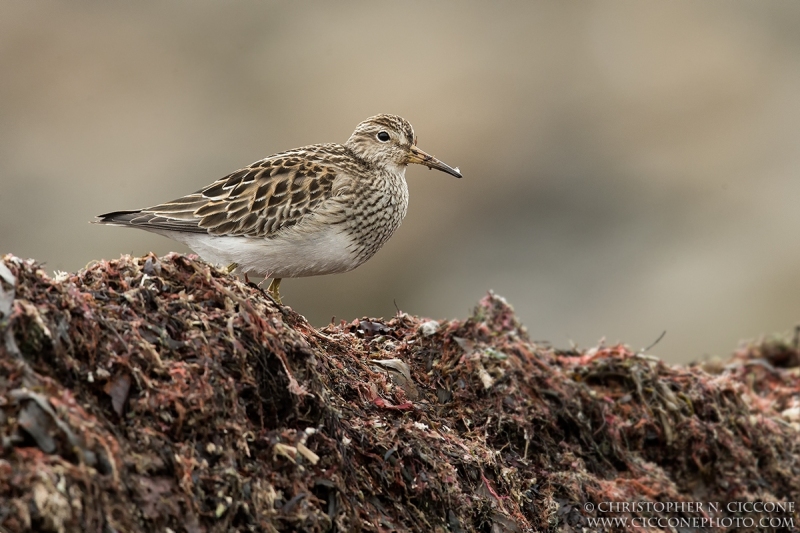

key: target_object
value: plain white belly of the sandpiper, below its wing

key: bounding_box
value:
[163,226,363,278]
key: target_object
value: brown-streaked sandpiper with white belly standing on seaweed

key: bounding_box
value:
[95,115,461,303]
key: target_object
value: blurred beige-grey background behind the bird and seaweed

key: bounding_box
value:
[0,0,800,361]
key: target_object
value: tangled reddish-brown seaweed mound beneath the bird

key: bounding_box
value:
[0,254,800,532]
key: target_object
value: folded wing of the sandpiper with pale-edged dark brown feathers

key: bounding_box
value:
[98,144,346,237]
